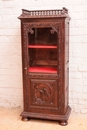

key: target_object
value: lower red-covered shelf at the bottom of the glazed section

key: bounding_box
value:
[28,67,57,73]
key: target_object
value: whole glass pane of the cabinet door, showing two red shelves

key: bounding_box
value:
[28,27,58,73]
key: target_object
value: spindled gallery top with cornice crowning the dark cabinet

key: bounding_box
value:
[19,7,69,19]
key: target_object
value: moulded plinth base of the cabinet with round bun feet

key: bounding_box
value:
[21,106,71,126]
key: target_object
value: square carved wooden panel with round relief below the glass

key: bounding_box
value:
[31,80,57,106]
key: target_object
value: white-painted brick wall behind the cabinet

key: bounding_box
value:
[0,0,87,113]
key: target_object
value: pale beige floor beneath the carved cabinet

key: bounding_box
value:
[0,108,87,130]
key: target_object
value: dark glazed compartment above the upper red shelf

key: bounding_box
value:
[28,27,57,46]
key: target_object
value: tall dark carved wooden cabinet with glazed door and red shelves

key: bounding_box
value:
[19,8,71,125]
